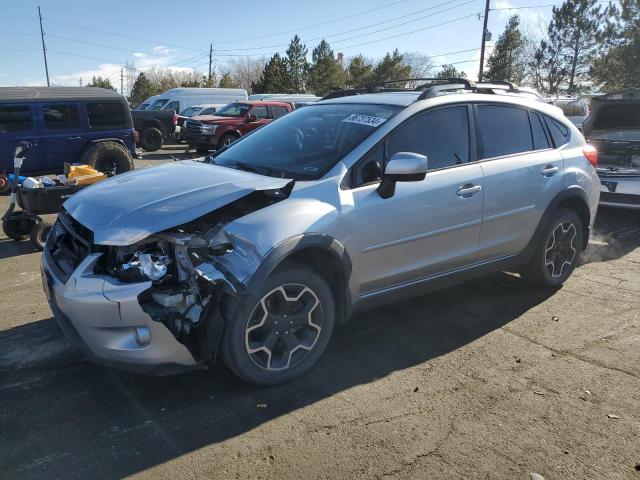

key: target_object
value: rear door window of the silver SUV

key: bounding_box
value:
[476,105,533,158]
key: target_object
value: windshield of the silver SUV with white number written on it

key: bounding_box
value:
[211,103,400,180]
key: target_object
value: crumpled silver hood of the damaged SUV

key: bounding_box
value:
[64,161,291,245]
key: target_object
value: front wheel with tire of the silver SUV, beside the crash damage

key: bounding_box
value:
[222,263,335,386]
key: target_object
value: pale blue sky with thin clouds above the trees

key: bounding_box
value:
[0,0,561,86]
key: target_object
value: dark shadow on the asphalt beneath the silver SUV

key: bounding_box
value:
[0,273,554,478]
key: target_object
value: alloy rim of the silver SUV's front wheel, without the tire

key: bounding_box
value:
[245,284,322,371]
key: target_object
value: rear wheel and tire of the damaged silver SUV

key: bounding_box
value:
[520,208,583,288]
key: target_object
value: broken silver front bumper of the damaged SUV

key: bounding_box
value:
[41,249,198,375]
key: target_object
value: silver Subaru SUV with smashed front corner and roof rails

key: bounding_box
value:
[42,79,600,385]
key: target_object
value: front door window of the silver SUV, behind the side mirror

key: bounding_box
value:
[387,105,469,170]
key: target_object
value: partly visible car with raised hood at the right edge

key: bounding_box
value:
[582,88,640,209]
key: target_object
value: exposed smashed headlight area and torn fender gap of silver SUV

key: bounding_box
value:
[95,183,293,364]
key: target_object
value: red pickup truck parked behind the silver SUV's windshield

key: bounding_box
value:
[182,101,293,153]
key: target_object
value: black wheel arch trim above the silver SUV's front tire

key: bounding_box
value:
[284,247,348,322]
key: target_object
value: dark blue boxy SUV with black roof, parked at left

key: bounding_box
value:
[0,87,136,175]
